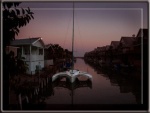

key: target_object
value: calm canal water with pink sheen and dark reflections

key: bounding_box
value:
[39,58,141,110]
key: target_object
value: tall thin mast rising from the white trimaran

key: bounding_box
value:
[72,1,74,71]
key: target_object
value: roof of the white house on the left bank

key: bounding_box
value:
[10,37,44,46]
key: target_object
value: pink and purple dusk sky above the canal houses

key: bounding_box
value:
[16,2,148,56]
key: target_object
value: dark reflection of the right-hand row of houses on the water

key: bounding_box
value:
[85,61,142,104]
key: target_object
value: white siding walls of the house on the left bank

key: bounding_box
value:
[12,39,44,74]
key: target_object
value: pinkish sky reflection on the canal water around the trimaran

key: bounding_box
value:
[46,59,137,105]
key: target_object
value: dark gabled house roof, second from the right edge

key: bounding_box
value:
[120,37,135,47]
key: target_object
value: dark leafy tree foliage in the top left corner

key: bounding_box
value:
[3,2,34,47]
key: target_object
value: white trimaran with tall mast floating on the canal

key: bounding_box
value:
[52,2,92,83]
